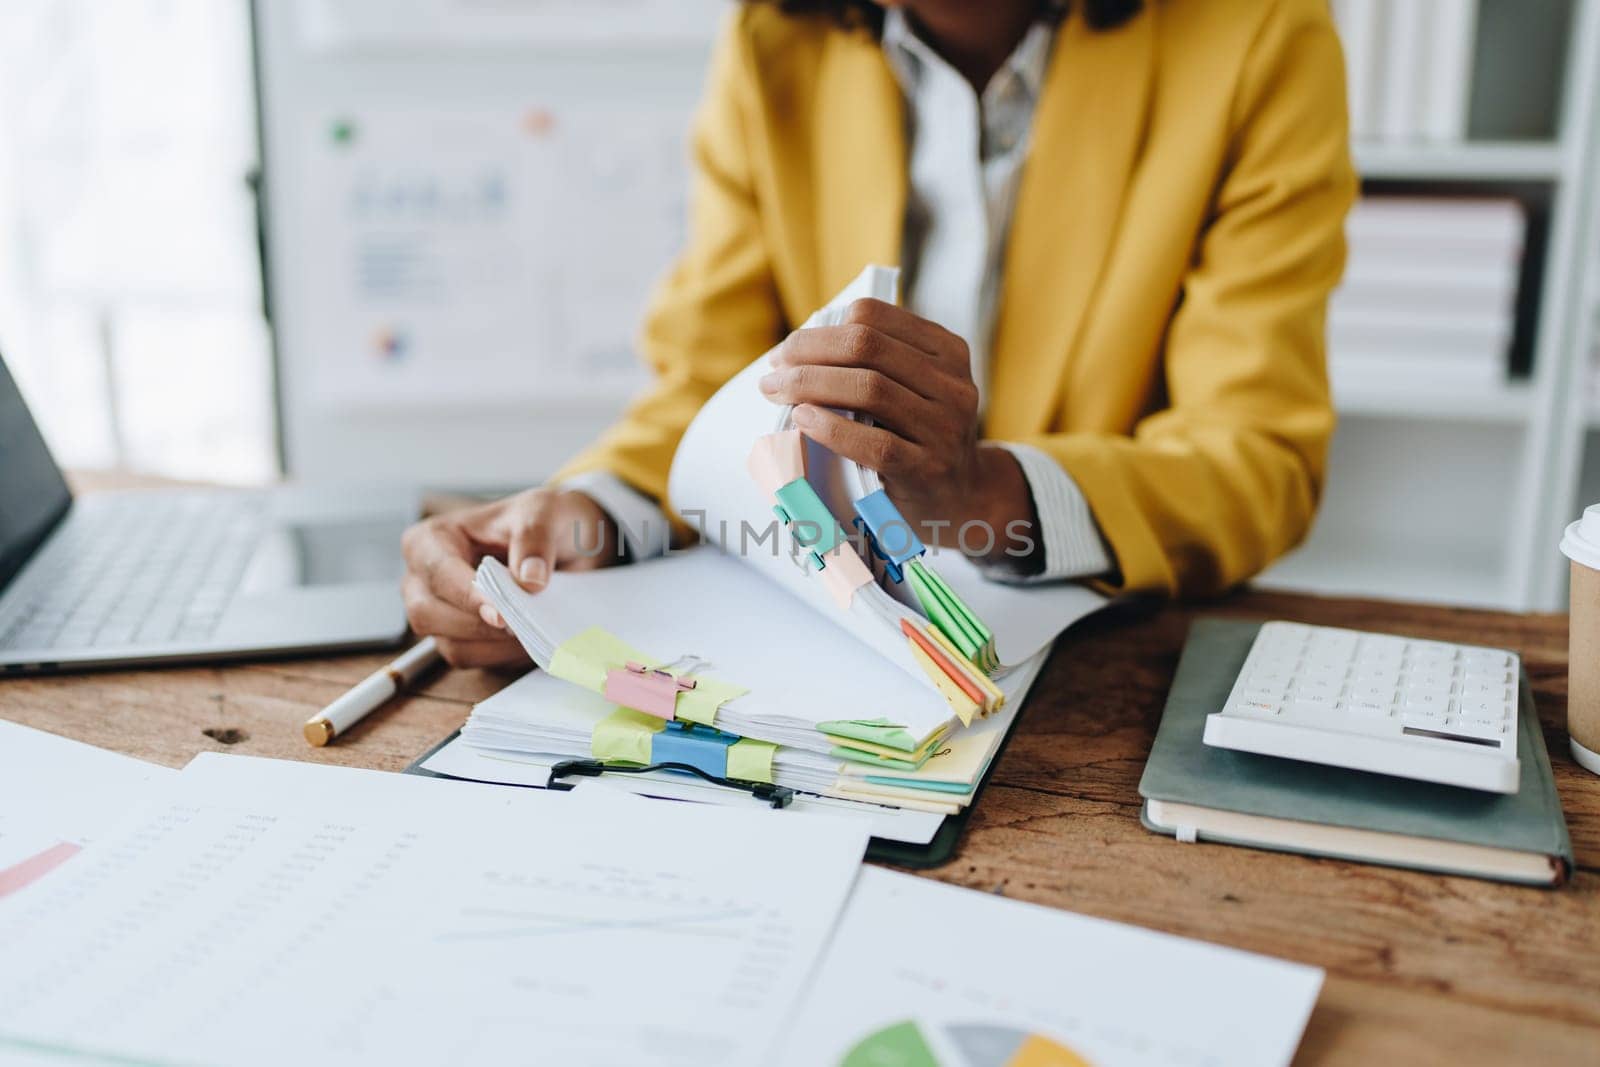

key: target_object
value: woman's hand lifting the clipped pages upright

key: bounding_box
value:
[762,299,1034,558]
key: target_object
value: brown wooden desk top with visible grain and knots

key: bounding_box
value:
[0,486,1600,1065]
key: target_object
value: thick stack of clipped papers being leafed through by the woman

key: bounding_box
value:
[462,267,1104,813]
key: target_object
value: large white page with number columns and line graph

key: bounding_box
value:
[0,755,867,1064]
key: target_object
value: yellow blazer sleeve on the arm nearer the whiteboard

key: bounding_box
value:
[554,14,782,514]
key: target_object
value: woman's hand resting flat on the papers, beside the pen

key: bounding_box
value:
[402,488,621,667]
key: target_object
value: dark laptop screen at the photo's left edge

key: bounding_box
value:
[0,351,72,587]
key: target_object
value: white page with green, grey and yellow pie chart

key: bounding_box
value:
[770,867,1322,1067]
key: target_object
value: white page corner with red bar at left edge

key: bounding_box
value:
[0,720,178,897]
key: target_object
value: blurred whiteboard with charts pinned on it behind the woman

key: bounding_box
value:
[254,0,726,488]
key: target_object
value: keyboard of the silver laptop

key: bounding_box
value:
[0,493,266,649]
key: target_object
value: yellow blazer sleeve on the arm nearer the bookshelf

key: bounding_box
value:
[1026,3,1357,593]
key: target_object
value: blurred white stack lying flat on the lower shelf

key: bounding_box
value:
[1328,197,1526,395]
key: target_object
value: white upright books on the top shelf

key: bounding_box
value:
[1333,0,1478,142]
